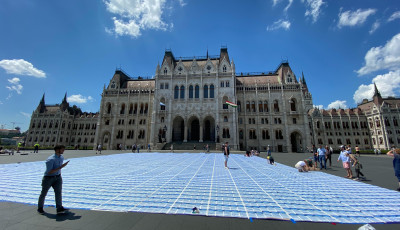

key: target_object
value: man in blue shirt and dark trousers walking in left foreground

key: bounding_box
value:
[37,145,69,215]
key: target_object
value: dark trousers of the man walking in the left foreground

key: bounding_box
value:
[38,175,62,208]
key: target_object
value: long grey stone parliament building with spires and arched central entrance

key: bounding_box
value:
[25,47,400,152]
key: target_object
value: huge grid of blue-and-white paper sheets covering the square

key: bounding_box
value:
[0,153,400,223]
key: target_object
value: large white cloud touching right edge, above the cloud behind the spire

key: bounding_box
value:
[357,33,400,75]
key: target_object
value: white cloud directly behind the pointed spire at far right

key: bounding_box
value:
[353,70,400,103]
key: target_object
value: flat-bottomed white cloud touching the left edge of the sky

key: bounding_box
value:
[0,59,46,78]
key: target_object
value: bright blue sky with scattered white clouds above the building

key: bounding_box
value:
[0,0,400,131]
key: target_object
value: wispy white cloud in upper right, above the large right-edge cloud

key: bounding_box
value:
[338,9,376,28]
